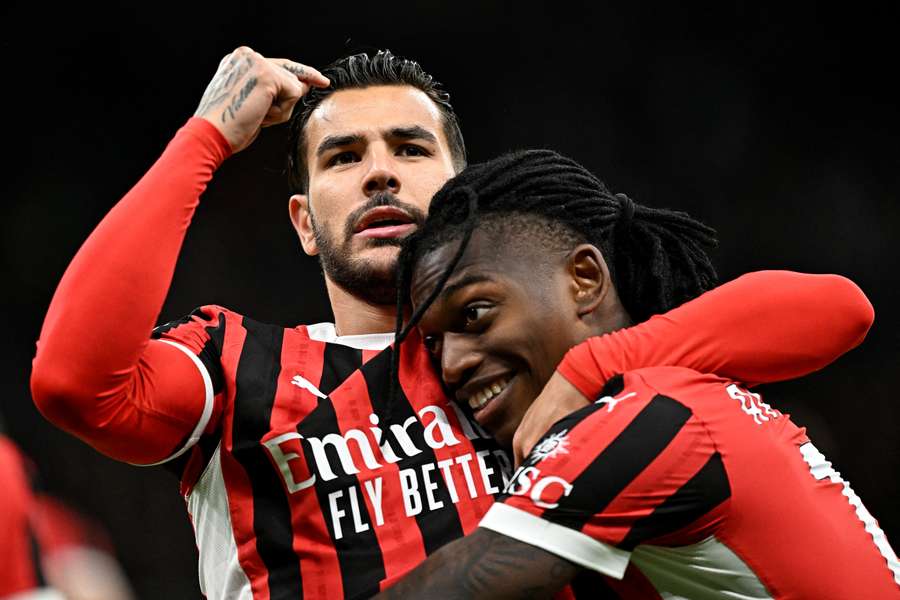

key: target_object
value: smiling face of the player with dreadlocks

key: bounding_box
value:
[411,230,589,444]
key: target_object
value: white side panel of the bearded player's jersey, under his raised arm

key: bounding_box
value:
[185,446,253,600]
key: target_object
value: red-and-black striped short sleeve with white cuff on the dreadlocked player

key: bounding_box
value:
[479,374,730,579]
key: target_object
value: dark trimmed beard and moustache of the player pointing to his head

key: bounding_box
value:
[310,192,425,306]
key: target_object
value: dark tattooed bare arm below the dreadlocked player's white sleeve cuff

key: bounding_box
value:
[379,529,580,600]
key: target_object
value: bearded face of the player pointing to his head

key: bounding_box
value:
[291,86,454,303]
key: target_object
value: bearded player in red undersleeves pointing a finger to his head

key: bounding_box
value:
[31,48,871,599]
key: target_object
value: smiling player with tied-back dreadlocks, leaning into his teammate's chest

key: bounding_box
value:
[379,151,900,600]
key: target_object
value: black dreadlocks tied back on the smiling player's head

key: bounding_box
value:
[391,150,716,414]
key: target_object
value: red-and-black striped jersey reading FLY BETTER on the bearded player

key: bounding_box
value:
[154,306,511,600]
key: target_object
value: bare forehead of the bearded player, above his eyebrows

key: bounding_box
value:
[306,85,446,148]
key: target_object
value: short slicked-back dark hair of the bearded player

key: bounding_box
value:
[287,50,466,193]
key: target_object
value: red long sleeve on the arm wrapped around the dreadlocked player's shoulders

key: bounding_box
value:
[558,271,875,398]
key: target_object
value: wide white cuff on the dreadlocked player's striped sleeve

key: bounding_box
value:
[478,502,629,579]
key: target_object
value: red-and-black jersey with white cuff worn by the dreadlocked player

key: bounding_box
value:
[481,367,900,599]
